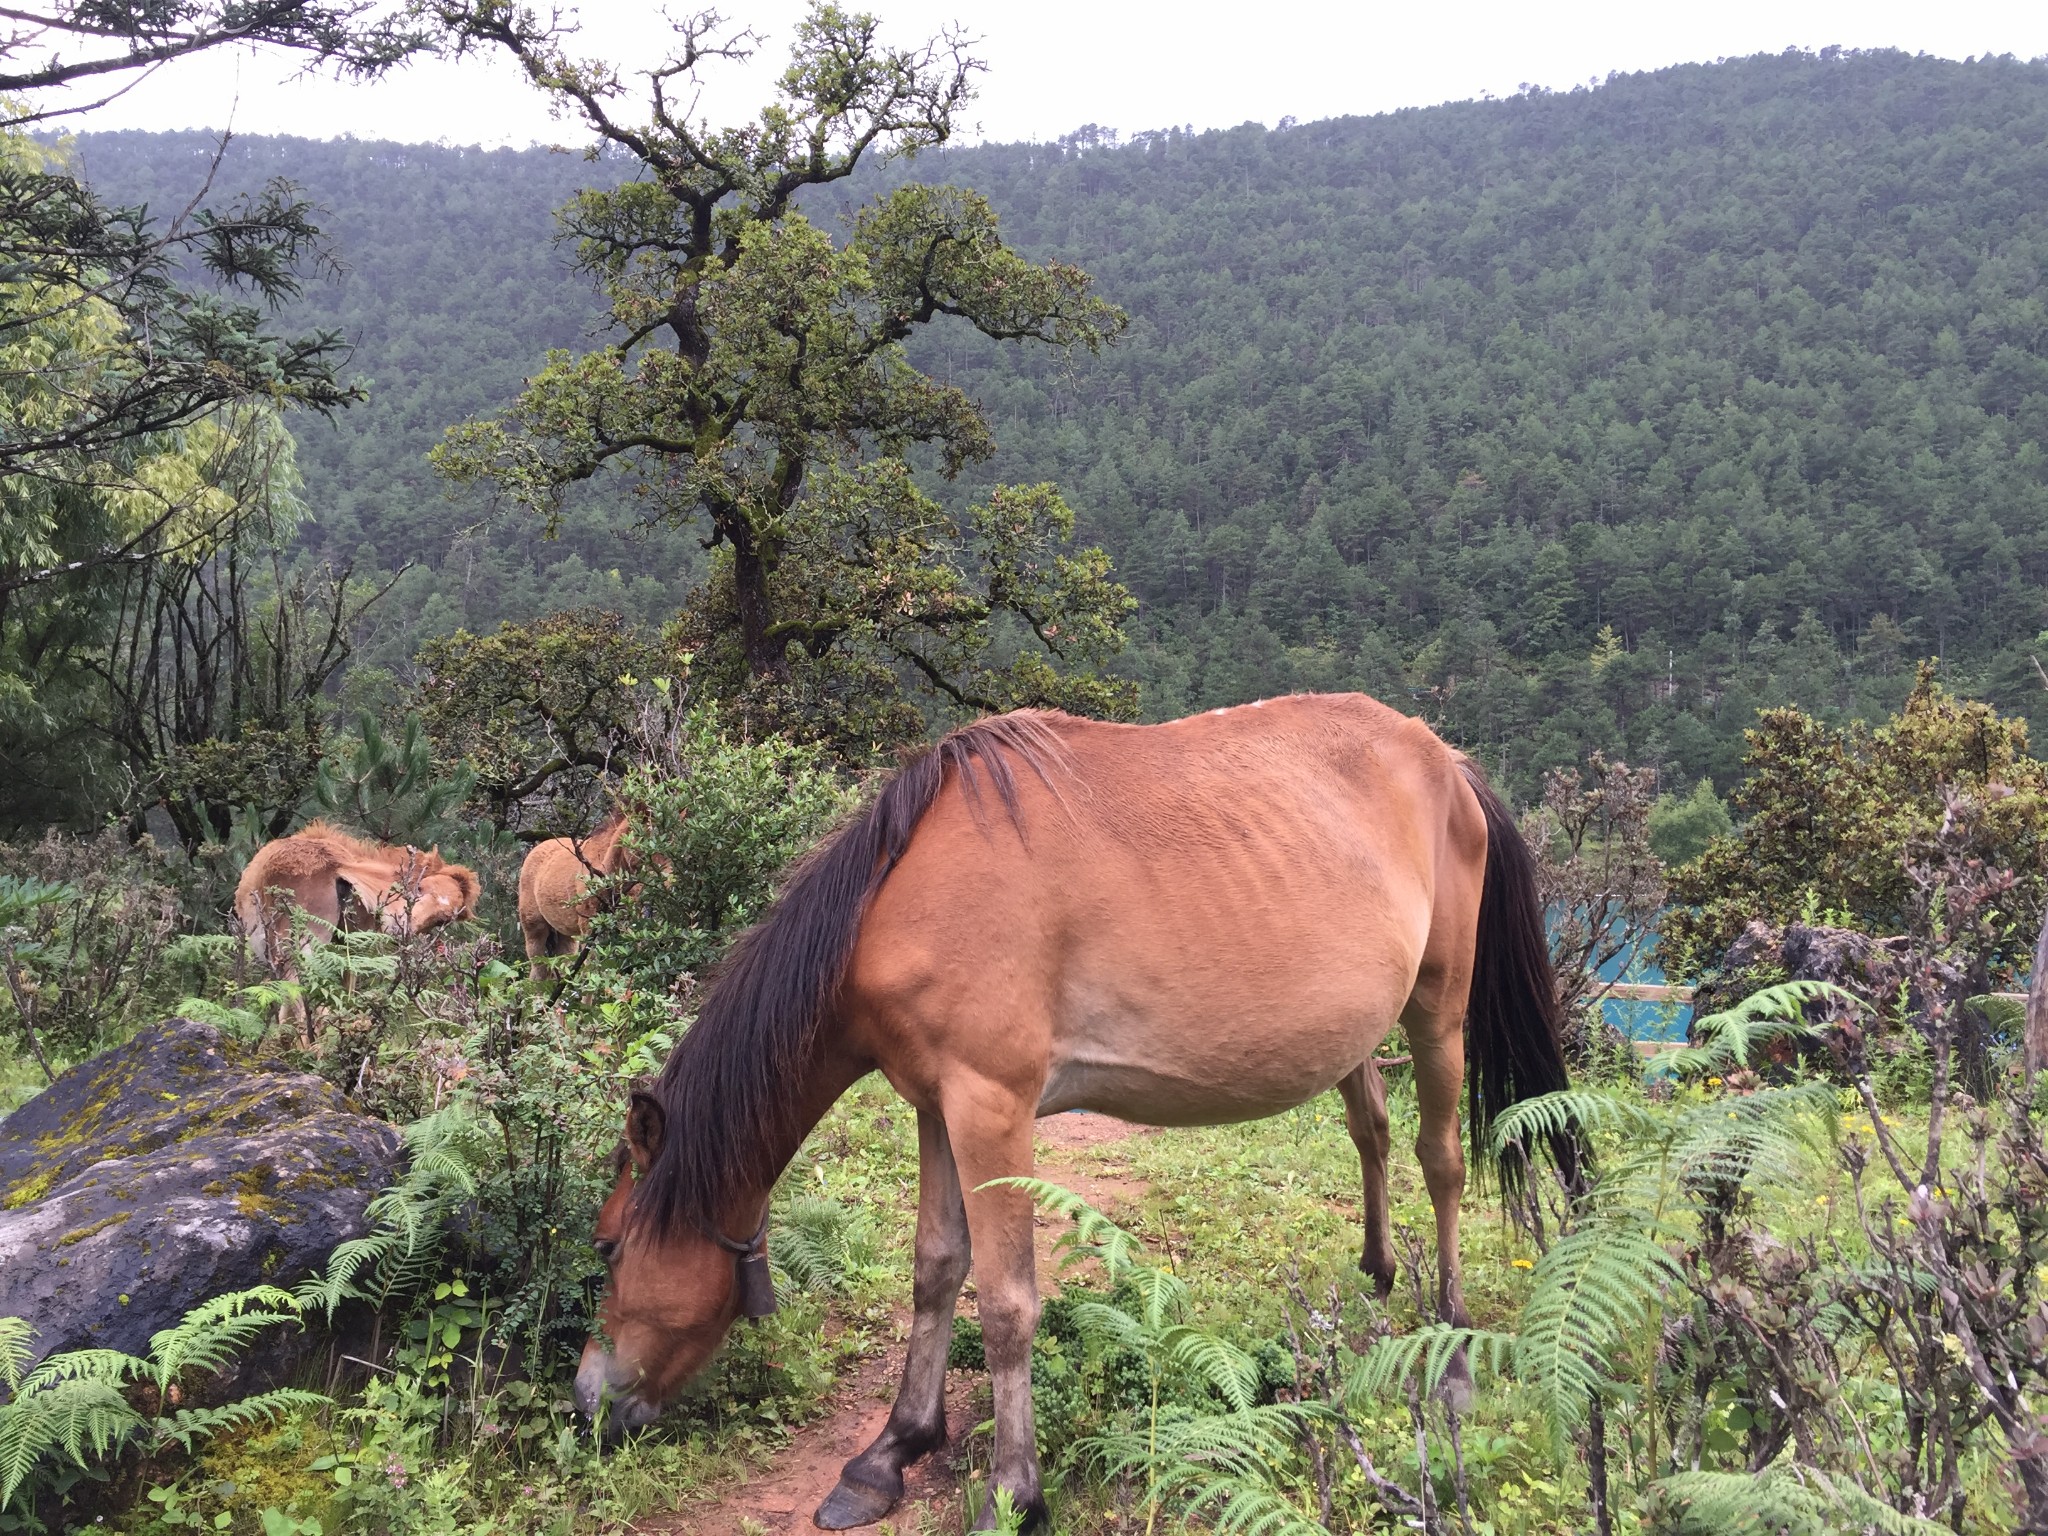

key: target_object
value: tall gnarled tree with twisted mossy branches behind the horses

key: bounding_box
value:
[436,0,1135,750]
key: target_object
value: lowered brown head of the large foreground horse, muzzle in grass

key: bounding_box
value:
[575,1094,774,1430]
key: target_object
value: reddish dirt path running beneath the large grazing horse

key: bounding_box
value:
[635,1114,1151,1536]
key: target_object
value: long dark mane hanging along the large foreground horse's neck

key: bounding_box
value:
[633,711,1063,1237]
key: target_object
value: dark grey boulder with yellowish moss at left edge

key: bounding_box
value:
[0,1018,399,1356]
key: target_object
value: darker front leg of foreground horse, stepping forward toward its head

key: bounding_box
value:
[813,1110,969,1530]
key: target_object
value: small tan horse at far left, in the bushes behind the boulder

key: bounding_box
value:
[236,821,483,1034]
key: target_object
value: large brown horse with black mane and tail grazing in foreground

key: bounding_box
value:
[575,694,1569,1530]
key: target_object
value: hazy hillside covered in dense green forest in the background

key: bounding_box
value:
[80,53,2048,791]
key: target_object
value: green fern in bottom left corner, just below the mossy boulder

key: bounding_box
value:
[0,1286,328,1509]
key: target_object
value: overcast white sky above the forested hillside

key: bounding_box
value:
[44,0,2048,145]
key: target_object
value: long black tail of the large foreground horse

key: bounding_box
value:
[1462,762,1579,1194]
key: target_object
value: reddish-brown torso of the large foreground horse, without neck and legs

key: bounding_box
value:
[850,694,1485,1122]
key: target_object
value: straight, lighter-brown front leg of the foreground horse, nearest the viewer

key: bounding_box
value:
[946,1079,1047,1530]
